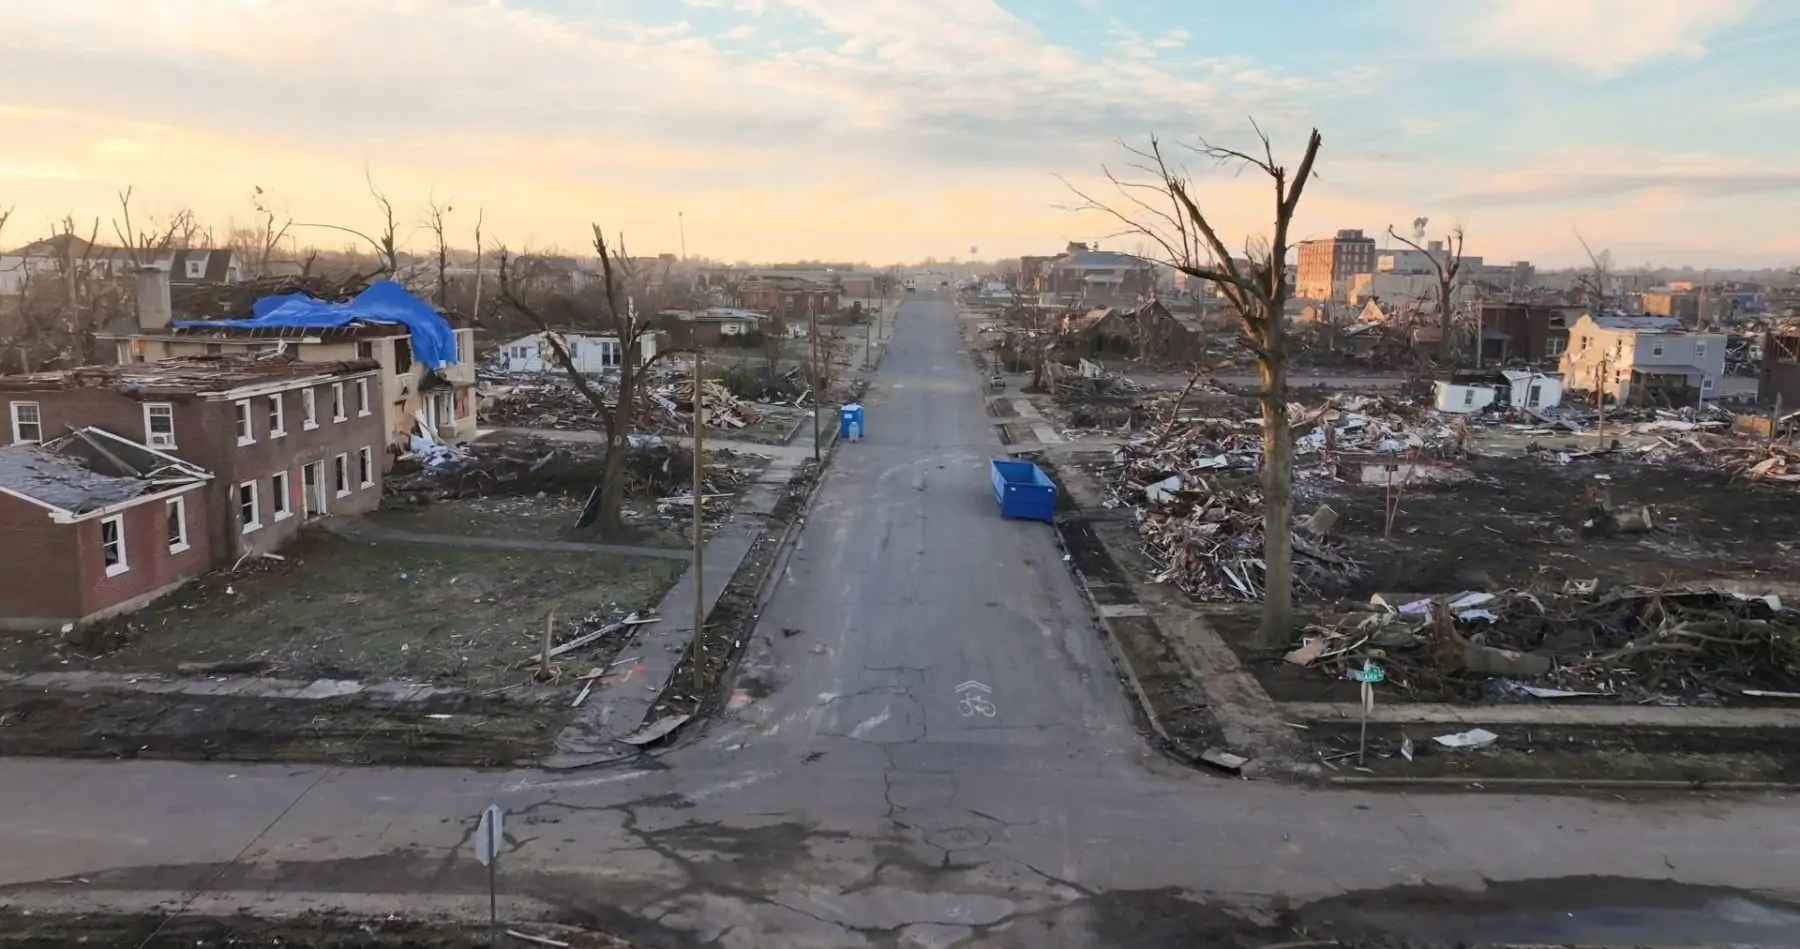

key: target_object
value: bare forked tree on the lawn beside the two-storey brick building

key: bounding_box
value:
[495,223,684,538]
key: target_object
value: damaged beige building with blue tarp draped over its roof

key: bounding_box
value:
[97,272,475,465]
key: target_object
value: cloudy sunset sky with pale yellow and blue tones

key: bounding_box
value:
[0,0,1800,267]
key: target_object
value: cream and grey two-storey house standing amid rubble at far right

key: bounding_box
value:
[1561,315,1726,407]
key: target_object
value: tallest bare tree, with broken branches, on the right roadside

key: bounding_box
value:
[1066,121,1321,646]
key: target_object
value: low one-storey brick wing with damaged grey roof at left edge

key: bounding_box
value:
[0,429,212,630]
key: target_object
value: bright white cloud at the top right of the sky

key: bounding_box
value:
[1454,0,1757,79]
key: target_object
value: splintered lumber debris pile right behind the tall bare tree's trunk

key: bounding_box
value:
[1103,432,1359,600]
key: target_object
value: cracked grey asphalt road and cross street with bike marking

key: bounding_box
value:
[0,297,1800,949]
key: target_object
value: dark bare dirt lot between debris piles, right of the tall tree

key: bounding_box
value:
[1294,456,1800,598]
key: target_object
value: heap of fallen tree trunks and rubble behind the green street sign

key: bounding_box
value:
[1287,582,1800,704]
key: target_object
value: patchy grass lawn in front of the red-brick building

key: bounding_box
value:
[0,533,684,690]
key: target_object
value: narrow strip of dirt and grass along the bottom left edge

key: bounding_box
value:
[0,911,630,949]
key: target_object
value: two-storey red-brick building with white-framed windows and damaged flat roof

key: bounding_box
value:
[0,355,385,564]
